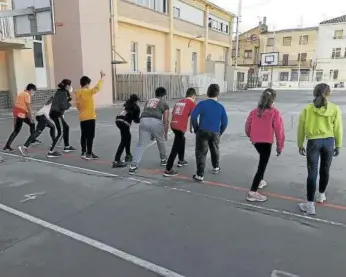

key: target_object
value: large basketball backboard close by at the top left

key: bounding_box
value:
[12,0,55,37]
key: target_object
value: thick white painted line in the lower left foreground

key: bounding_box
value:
[0,201,184,277]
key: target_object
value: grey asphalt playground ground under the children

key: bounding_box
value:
[0,91,346,277]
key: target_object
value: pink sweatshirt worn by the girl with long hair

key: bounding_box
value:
[245,108,285,152]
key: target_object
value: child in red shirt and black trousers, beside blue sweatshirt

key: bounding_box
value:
[163,88,196,177]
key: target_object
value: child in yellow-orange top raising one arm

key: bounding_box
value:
[76,71,106,160]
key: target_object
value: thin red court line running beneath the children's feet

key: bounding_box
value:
[0,144,346,211]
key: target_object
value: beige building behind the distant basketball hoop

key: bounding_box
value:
[260,27,318,87]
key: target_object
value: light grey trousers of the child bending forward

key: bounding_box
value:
[131,117,166,167]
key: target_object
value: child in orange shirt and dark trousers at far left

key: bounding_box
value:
[4,84,39,152]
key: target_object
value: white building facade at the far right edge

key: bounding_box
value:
[314,15,346,87]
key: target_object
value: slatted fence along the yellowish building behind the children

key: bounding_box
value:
[116,73,215,101]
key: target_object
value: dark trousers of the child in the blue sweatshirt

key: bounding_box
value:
[195,130,220,177]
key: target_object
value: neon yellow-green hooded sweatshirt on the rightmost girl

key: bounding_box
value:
[298,102,343,148]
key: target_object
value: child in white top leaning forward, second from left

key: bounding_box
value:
[18,97,55,156]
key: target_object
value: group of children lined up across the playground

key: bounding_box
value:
[4,76,343,215]
